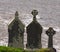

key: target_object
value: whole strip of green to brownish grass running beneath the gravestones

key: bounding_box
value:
[0,46,50,52]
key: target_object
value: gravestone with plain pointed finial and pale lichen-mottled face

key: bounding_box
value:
[8,11,24,48]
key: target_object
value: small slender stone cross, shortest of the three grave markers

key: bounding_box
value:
[46,27,56,48]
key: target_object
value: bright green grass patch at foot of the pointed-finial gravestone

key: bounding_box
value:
[0,46,23,52]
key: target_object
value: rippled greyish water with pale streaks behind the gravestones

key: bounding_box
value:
[0,0,60,52]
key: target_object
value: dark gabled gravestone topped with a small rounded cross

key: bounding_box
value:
[26,10,42,48]
